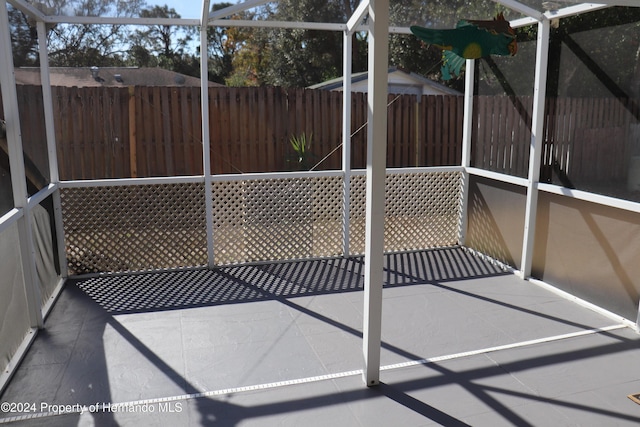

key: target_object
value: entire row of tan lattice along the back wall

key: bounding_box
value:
[62,172,461,274]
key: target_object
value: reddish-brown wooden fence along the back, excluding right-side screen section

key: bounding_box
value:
[3,86,462,180]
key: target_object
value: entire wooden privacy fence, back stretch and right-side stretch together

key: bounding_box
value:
[0,86,640,181]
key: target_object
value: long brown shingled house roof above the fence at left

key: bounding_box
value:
[15,67,222,87]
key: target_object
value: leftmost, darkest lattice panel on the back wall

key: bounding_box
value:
[61,184,207,274]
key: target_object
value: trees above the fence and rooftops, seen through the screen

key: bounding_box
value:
[8,0,640,97]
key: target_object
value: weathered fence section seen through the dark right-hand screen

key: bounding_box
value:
[472,96,640,186]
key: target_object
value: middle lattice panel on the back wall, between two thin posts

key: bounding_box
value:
[213,177,342,265]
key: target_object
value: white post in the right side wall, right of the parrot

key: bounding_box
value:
[520,18,551,278]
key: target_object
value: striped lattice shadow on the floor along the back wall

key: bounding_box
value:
[74,247,506,314]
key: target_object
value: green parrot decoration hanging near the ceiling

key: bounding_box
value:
[410,13,518,80]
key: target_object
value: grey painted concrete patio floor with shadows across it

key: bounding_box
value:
[0,247,640,426]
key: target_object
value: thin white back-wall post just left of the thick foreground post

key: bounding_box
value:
[342,31,353,257]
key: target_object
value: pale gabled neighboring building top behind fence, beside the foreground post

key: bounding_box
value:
[309,67,462,95]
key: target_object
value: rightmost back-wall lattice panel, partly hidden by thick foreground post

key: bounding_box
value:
[349,172,462,254]
